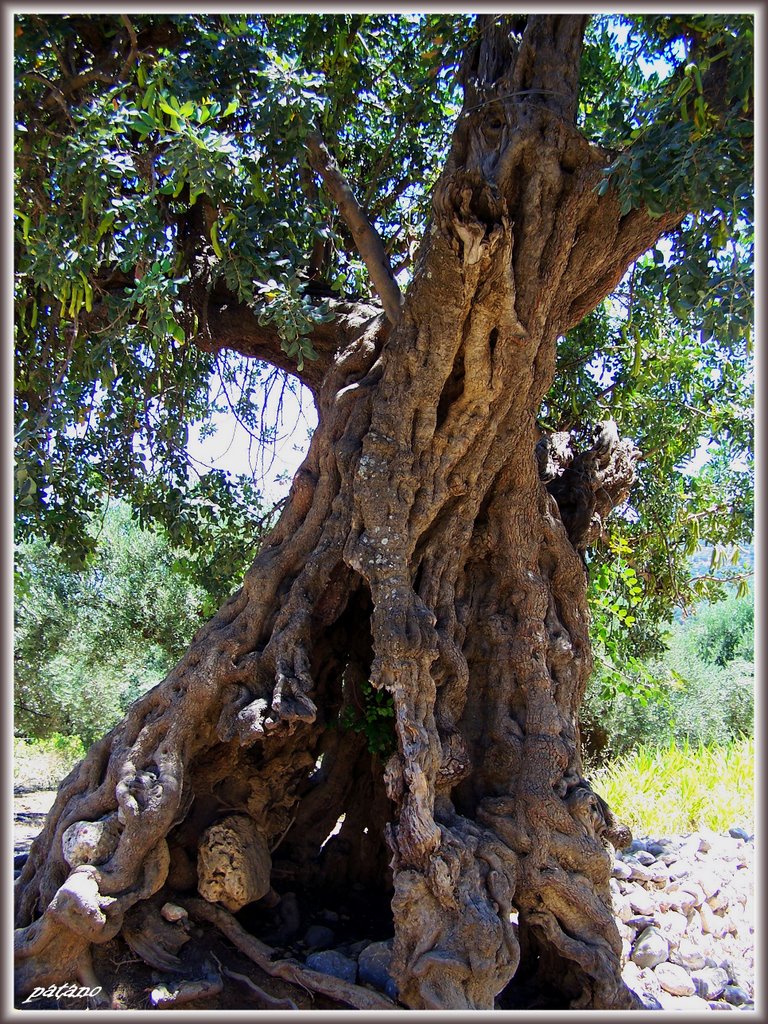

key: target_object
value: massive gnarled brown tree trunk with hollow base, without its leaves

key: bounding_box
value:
[16,15,680,1009]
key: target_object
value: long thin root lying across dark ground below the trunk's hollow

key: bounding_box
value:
[178,898,396,1010]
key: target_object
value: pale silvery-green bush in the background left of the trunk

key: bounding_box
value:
[14,506,217,743]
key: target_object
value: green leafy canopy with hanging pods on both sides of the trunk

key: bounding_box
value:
[14,13,754,678]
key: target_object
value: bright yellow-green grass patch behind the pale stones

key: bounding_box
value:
[592,736,755,836]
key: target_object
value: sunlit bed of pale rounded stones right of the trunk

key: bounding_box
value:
[611,825,755,1013]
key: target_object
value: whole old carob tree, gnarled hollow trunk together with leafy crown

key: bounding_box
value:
[15,14,749,1009]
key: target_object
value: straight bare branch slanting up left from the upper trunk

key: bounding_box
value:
[307,133,402,324]
